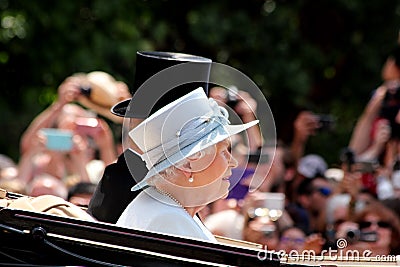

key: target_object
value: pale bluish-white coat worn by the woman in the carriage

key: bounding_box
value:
[117,187,217,242]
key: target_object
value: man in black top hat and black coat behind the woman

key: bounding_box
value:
[88,52,212,223]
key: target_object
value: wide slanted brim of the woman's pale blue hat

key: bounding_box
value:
[131,120,258,191]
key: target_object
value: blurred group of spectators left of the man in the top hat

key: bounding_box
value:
[0,71,130,207]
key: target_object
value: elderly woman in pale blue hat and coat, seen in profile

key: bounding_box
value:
[117,88,258,242]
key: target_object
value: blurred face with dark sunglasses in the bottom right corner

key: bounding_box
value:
[360,213,392,248]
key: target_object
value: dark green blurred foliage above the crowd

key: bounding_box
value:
[0,0,400,163]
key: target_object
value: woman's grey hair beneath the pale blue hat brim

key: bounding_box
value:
[148,144,215,185]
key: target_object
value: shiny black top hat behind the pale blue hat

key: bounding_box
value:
[111,51,212,118]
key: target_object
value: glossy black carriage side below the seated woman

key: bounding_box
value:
[0,208,281,266]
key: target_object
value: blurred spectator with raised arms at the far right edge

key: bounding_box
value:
[349,44,400,200]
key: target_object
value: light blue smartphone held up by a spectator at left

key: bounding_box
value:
[40,128,73,151]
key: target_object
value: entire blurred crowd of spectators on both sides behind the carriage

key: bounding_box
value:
[0,48,400,260]
